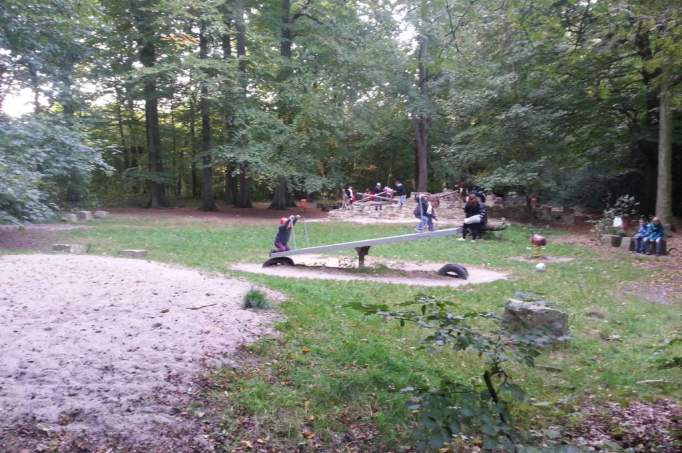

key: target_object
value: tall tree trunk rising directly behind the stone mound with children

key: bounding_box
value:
[413,35,431,192]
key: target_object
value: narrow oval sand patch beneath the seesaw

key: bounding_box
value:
[231,255,507,287]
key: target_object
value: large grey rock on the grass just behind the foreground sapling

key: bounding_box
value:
[502,299,569,342]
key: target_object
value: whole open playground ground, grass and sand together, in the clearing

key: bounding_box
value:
[0,209,682,452]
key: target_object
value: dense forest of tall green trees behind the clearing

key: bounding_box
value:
[0,0,682,223]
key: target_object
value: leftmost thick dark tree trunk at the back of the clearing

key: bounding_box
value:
[140,40,166,208]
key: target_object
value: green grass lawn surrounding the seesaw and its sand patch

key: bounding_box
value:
[59,220,682,451]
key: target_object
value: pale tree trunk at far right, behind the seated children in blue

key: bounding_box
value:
[656,79,673,228]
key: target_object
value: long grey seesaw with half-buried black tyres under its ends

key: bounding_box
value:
[263,228,469,280]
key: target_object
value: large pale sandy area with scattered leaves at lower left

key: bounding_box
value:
[0,255,274,451]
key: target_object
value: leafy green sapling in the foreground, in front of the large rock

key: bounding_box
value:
[351,295,544,451]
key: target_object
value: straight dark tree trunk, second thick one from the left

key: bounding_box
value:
[199,22,217,211]
